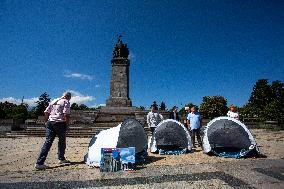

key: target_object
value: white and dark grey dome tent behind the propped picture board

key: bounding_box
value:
[84,118,147,167]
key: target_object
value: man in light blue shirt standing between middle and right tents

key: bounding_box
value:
[187,106,202,148]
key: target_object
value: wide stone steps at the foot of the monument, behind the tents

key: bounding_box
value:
[2,108,164,138]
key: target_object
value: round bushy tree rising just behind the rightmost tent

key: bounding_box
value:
[200,96,228,119]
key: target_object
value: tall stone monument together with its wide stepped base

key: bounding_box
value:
[10,36,169,137]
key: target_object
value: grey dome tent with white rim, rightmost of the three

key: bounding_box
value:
[203,117,259,158]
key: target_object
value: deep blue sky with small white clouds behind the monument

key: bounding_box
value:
[0,0,284,107]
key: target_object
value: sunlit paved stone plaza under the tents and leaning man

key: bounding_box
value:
[0,130,284,188]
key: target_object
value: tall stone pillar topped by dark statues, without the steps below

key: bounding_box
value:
[106,36,132,107]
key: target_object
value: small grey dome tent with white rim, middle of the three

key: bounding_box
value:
[149,119,192,154]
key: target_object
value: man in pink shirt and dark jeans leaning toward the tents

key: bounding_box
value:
[35,92,71,170]
